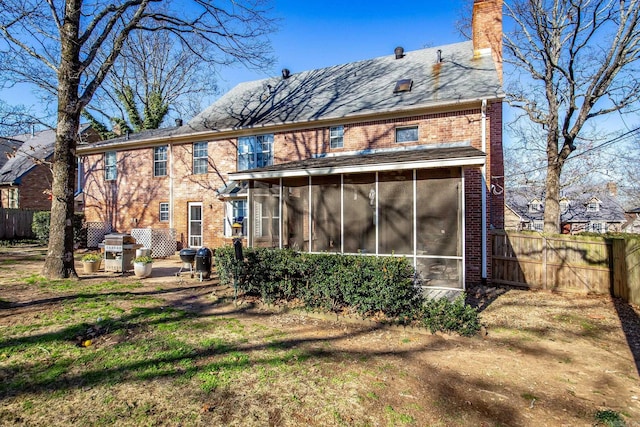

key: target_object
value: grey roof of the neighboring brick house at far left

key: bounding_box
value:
[0,125,90,185]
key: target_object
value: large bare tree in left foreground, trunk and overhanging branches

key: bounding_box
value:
[0,0,273,278]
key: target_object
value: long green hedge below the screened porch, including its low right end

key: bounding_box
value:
[214,246,480,335]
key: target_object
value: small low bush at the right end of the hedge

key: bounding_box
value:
[421,294,480,336]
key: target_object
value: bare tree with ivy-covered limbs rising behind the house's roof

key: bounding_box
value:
[86,32,217,132]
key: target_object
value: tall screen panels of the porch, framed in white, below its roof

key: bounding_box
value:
[248,167,464,289]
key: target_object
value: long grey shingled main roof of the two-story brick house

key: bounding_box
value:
[80,41,504,152]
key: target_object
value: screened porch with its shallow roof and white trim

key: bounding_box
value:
[230,146,485,289]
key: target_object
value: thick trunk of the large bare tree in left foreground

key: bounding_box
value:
[42,0,82,279]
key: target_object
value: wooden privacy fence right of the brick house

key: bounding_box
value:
[492,231,640,304]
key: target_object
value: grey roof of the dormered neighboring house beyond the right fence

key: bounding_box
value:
[505,188,626,223]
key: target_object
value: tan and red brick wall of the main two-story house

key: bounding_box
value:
[83,102,504,283]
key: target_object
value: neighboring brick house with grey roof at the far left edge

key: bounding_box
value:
[0,125,99,210]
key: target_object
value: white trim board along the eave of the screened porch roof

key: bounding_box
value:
[229,156,486,181]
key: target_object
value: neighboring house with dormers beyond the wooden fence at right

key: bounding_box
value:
[505,183,626,234]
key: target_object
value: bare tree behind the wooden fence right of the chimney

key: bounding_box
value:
[504,0,640,233]
